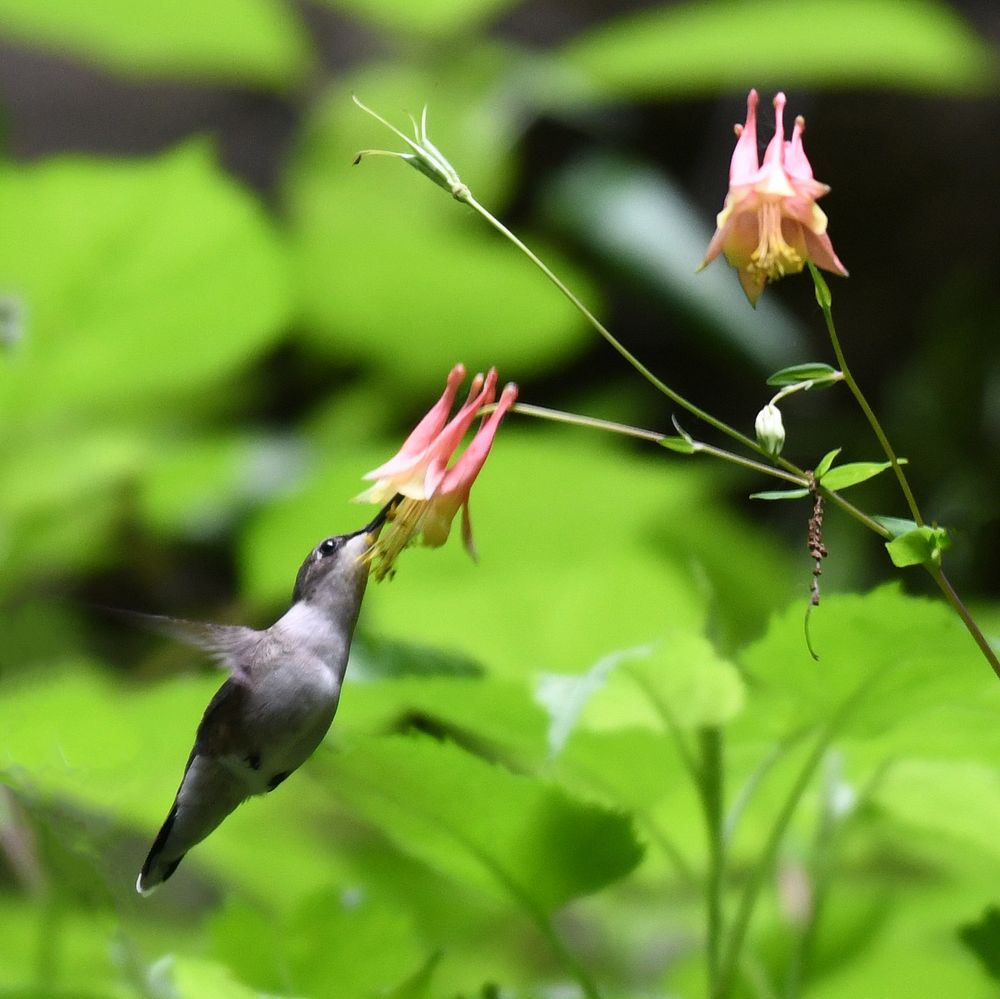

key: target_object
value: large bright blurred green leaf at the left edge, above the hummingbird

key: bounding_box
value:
[0,143,291,420]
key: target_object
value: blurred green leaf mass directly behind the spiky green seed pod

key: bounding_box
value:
[288,52,599,394]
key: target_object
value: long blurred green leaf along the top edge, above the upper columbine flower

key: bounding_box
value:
[563,0,995,97]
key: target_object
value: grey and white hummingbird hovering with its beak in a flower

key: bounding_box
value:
[135,497,399,895]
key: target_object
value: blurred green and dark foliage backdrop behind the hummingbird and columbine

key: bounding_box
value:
[0,0,1000,999]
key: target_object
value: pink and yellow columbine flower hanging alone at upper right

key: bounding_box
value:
[702,90,847,305]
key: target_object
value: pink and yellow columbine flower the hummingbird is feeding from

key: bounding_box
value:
[357,364,517,580]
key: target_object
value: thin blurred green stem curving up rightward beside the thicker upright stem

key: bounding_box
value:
[710,677,877,999]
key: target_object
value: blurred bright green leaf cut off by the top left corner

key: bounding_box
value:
[0,0,310,88]
